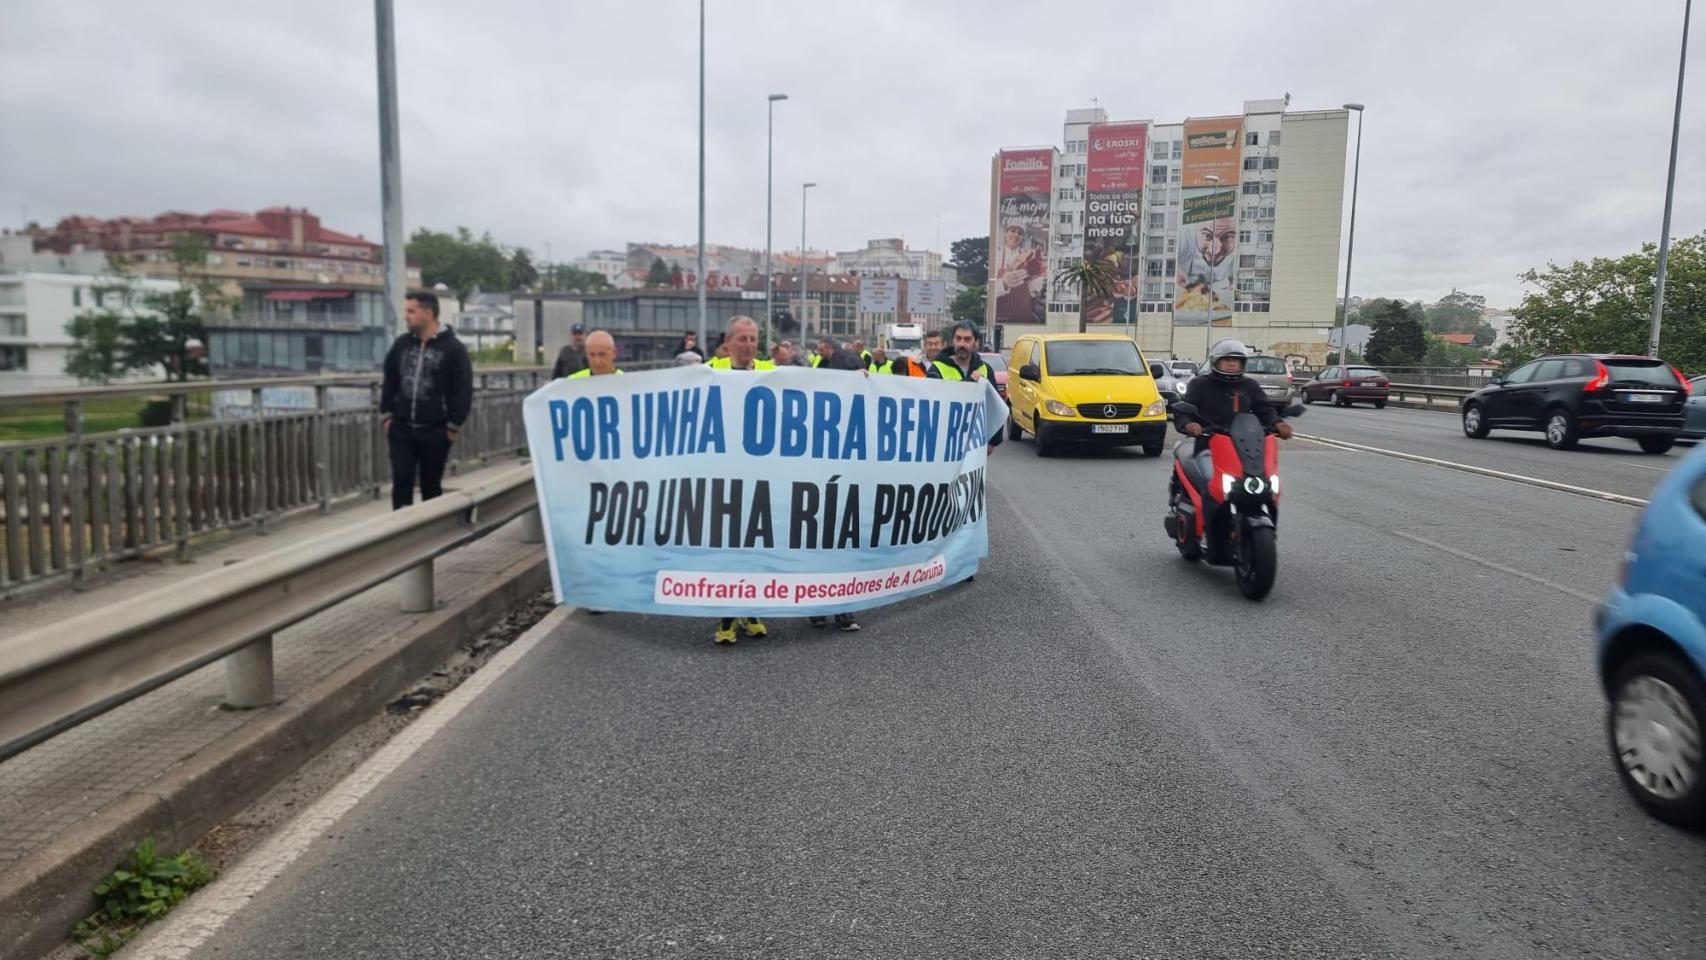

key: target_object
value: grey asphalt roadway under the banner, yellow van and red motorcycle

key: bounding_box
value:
[169,429,1706,960]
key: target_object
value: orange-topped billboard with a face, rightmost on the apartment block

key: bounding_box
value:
[1174,116,1244,326]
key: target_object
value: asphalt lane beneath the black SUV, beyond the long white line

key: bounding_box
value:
[1297,402,1691,498]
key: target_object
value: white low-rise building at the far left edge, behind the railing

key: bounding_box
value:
[0,234,177,394]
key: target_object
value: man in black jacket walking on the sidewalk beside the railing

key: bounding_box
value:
[379,293,474,510]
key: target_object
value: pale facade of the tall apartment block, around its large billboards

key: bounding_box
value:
[1005,99,1349,363]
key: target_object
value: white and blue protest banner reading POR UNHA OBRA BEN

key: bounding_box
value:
[522,365,1007,617]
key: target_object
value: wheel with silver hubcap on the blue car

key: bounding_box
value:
[1605,651,1706,830]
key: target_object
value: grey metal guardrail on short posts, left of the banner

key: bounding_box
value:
[0,466,544,759]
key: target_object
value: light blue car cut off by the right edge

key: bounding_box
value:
[1595,447,1706,829]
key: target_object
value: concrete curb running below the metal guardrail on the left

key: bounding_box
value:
[0,551,551,960]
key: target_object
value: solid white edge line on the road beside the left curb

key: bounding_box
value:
[125,607,575,960]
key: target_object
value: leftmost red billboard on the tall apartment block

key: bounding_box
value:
[989,147,1054,324]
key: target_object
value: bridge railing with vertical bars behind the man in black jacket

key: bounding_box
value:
[0,363,650,597]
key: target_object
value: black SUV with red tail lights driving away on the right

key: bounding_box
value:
[1462,353,1689,454]
